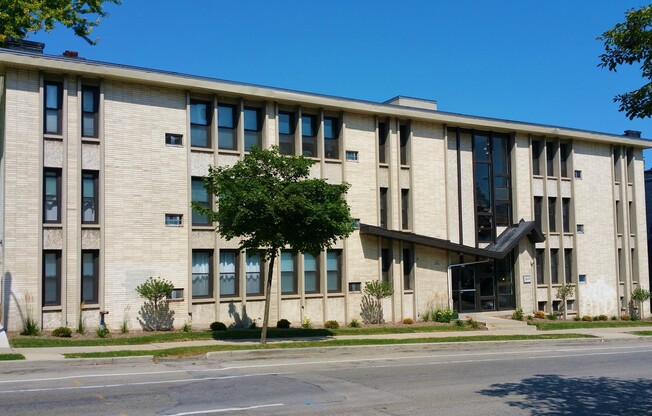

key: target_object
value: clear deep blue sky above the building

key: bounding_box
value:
[29,0,652,169]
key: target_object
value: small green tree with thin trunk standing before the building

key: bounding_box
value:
[193,146,354,345]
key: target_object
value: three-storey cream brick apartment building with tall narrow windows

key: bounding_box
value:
[0,43,650,330]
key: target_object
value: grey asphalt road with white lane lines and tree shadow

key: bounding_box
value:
[0,339,652,416]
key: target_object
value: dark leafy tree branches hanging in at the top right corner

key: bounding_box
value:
[598,5,652,120]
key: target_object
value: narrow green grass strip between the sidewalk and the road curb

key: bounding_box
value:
[64,334,595,358]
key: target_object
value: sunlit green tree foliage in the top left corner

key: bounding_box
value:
[0,0,121,45]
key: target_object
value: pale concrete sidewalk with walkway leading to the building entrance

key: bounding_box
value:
[0,312,652,366]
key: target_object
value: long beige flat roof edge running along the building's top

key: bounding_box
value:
[0,48,652,148]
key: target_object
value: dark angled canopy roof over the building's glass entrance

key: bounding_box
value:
[360,220,546,260]
